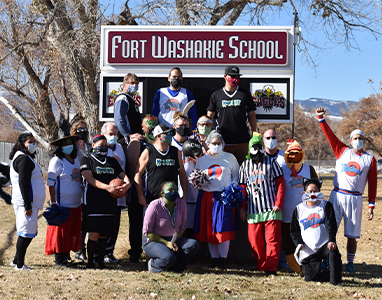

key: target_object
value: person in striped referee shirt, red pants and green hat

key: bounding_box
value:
[239,132,285,275]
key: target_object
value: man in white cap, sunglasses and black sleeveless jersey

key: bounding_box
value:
[134,124,188,207]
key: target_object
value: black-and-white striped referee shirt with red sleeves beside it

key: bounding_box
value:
[239,156,283,215]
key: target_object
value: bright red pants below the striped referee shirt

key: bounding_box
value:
[248,220,281,272]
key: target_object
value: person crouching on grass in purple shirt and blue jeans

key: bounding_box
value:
[142,181,199,273]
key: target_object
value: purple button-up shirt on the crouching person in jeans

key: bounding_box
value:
[143,198,187,236]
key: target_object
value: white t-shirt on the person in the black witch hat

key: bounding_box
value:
[46,156,82,208]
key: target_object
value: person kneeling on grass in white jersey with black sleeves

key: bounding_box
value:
[290,178,342,285]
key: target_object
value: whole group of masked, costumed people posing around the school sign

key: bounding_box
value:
[4,62,376,284]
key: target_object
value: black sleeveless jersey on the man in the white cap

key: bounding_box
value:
[146,146,179,203]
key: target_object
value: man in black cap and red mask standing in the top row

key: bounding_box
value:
[207,66,257,165]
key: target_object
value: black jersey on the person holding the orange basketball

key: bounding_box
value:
[80,155,123,215]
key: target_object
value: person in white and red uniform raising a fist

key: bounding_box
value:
[316,107,378,273]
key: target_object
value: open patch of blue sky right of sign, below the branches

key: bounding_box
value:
[295,32,382,101]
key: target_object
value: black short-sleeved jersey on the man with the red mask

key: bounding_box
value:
[207,86,256,144]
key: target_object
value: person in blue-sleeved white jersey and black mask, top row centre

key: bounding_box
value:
[151,67,198,129]
